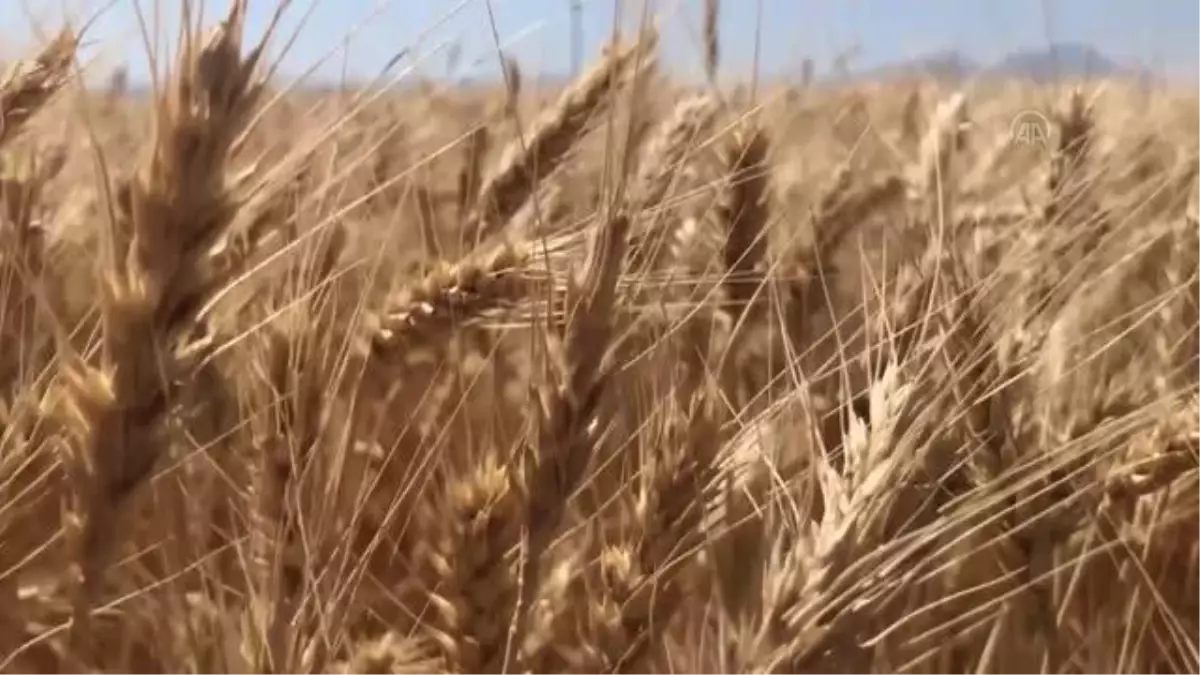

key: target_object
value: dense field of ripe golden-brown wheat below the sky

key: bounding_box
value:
[7,2,1200,675]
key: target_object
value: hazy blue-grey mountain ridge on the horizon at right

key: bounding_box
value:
[853,43,1148,82]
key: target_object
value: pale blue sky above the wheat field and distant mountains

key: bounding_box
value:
[0,0,1200,80]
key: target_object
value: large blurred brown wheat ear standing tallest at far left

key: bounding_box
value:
[59,1,262,653]
